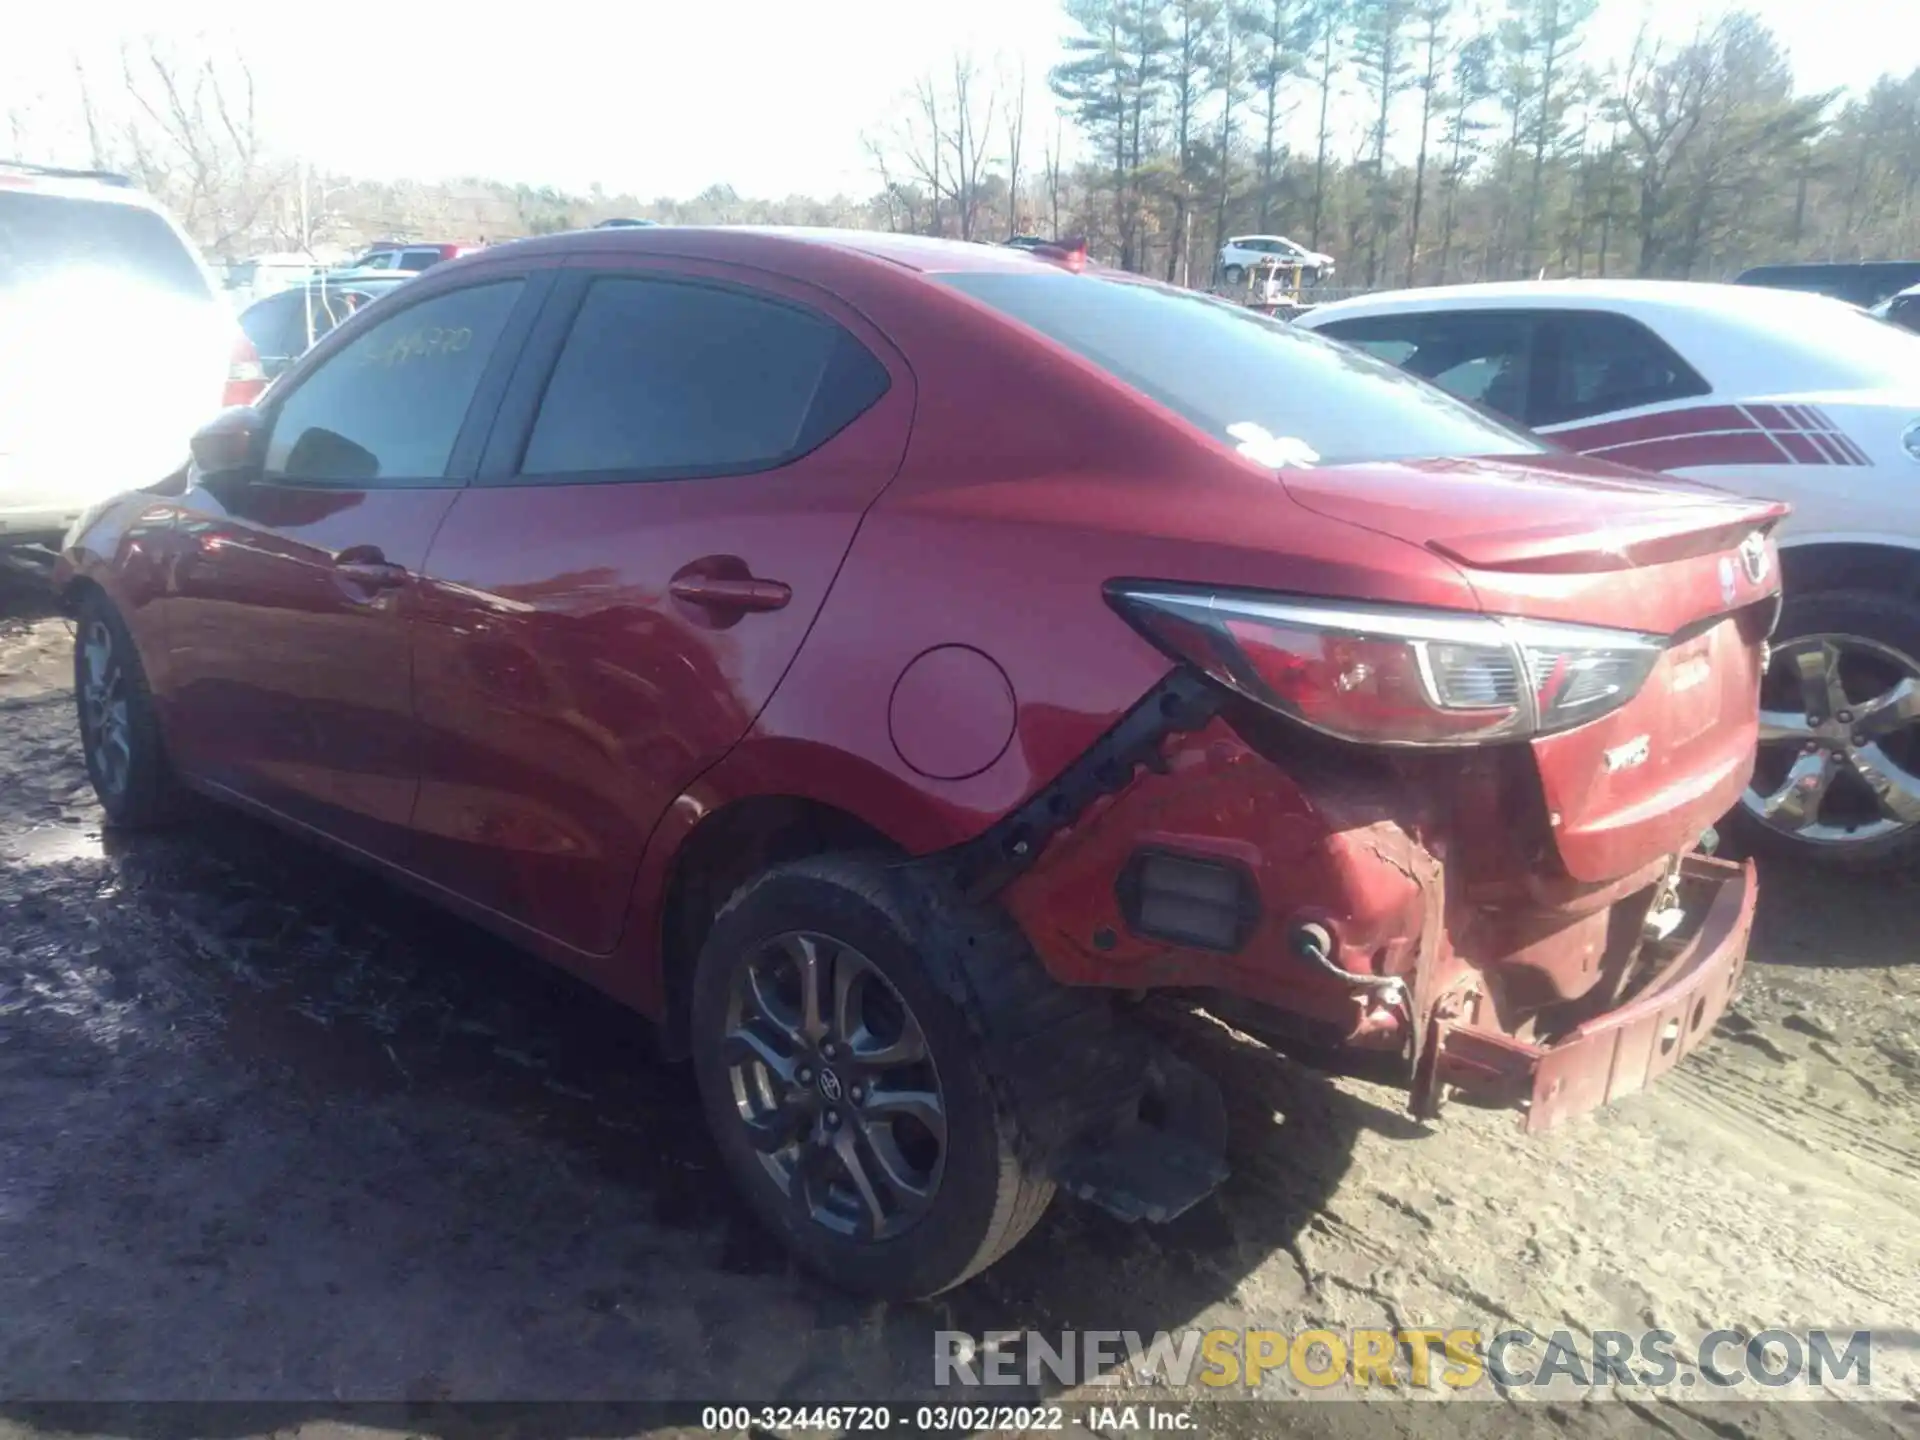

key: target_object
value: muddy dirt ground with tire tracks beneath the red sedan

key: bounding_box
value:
[0,568,1920,1436]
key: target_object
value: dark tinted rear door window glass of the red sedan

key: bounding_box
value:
[520,276,887,480]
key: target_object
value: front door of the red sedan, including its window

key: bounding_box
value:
[165,278,526,860]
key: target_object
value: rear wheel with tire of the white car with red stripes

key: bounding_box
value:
[1732,591,1920,866]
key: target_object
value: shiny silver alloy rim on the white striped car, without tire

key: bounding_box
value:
[1741,636,1920,847]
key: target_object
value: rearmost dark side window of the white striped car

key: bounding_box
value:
[1526,311,1713,424]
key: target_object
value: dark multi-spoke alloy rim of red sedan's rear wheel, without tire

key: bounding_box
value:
[722,931,947,1240]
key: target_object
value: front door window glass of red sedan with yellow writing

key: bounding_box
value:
[265,280,522,486]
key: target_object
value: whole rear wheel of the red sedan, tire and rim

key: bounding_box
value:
[691,856,1054,1300]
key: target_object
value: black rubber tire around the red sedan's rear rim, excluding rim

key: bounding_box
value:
[689,856,1062,1300]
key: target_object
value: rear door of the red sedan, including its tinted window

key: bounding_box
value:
[413,257,914,954]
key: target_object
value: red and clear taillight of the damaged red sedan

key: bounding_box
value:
[1108,584,1667,745]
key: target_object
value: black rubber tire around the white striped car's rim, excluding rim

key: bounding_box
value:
[1726,589,1920,870]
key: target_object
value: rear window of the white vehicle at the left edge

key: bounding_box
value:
[0,190,213,300]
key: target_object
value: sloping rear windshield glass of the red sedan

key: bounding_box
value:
[941,273,1548,465]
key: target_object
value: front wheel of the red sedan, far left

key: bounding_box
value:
[73,591,182,829]
